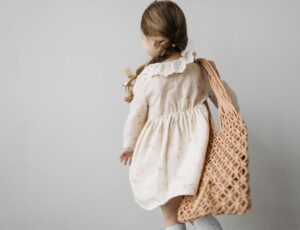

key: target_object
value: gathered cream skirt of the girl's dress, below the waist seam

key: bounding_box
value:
[129,103,209,210]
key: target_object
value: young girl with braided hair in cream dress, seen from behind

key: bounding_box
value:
[120,1,239,230]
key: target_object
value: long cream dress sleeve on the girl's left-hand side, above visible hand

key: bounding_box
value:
[122,76,148,152]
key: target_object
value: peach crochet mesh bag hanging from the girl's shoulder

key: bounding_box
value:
[177,58,252,222]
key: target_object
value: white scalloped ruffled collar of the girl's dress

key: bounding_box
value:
[141,50,197,77]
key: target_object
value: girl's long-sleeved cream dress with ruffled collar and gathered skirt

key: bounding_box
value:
[122,50,239,210]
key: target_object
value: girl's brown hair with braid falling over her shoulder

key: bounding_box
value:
[125,0,188,102]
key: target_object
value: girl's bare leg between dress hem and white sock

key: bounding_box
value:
[160,196,183,228]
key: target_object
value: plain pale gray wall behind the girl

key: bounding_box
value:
[0,0,300,230]
